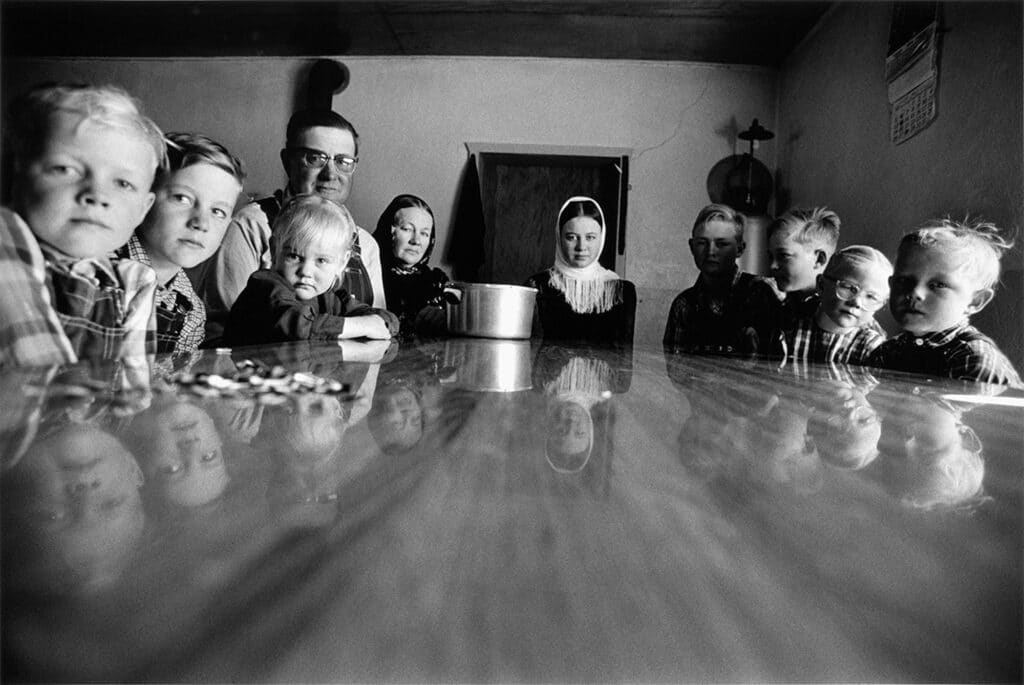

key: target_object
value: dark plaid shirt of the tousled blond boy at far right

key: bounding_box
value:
[868,320,1024,388]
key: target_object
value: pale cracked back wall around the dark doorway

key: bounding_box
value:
[3,56,776,345]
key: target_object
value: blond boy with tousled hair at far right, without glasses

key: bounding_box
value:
[870,219,1022,388]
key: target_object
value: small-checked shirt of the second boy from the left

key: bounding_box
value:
[117,234,206,354]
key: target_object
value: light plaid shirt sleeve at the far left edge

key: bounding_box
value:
[0,208,77,367]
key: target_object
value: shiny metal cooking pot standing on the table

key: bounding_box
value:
[444,283,538,339]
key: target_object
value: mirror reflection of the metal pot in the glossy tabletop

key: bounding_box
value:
[441,339,534,392]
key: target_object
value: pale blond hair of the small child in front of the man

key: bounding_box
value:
[271,194,355,266]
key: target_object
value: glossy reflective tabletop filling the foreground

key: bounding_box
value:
[0,339,1024,682]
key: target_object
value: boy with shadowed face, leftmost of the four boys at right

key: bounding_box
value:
[663,204,770,352]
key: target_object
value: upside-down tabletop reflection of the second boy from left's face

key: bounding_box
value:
[145,402,227,507]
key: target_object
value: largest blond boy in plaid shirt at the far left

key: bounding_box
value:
[0,85,166,366]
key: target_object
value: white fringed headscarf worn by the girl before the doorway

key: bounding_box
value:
[550,196,622,314]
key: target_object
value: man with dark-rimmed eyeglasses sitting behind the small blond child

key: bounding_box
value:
[191,110,386,347]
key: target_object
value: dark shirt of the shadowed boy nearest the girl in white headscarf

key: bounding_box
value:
[662,269,774,352]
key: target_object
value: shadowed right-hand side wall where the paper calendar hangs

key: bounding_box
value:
[777,2,1024,369]
